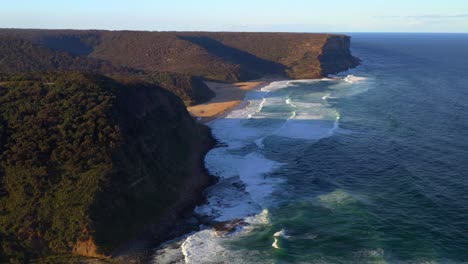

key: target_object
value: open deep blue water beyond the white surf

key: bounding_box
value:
[266,34,468,263]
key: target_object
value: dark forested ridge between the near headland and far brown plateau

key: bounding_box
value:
[0,36,214,105]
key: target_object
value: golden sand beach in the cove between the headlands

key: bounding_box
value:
[187,80,271,123]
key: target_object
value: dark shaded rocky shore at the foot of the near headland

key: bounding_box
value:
[111,125,218,264]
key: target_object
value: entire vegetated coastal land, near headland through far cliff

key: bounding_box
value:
[0,30,359,261]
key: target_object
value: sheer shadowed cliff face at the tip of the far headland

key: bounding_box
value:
[318,36,360,76]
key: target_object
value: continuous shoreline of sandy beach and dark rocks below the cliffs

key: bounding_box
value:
[103,78,280,263]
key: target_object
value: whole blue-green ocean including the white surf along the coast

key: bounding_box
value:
[154,33,468,263]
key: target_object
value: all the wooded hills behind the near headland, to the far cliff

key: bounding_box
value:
[0,29,358,105]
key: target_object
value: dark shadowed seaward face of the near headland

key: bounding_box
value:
[91,83,213,254]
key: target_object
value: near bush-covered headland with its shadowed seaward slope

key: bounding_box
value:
[0,73,212,261]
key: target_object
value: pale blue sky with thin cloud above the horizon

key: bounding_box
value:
[0,0,468,33]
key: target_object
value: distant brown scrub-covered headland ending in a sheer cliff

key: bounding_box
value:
[0,29,359,82]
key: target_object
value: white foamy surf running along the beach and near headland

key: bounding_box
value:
[172,76,361,263]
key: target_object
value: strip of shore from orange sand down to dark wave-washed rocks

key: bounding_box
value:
[113,75,344,263]
